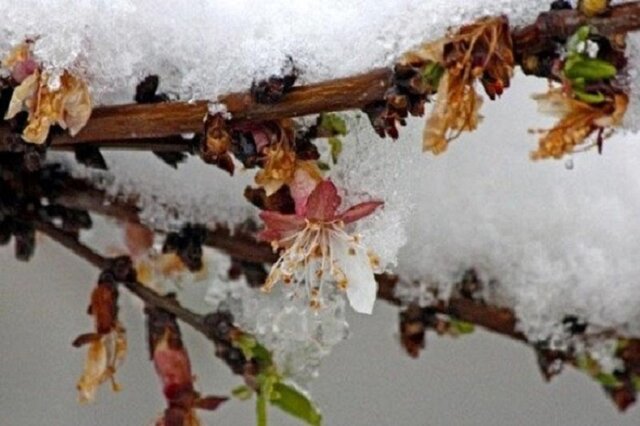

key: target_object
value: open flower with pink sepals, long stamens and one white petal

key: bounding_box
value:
[260,180,383,313]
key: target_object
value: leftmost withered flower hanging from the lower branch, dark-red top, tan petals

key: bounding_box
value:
[73,274,127,402]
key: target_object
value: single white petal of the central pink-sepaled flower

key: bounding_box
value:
[334,238,378,314]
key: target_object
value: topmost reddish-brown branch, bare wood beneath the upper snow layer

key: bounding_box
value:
[0,2,640,150]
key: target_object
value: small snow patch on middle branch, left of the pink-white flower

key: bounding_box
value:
[51,151,257,230]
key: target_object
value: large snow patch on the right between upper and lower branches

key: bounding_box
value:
[398,72,640,340]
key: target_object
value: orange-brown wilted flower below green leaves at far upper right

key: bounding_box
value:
[531,88,629,160]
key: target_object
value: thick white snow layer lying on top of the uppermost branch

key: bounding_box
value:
[0,0,548,104]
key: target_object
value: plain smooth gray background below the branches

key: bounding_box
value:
[0,239,640,426]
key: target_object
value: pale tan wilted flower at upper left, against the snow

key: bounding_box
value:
[5,70,91,144]
